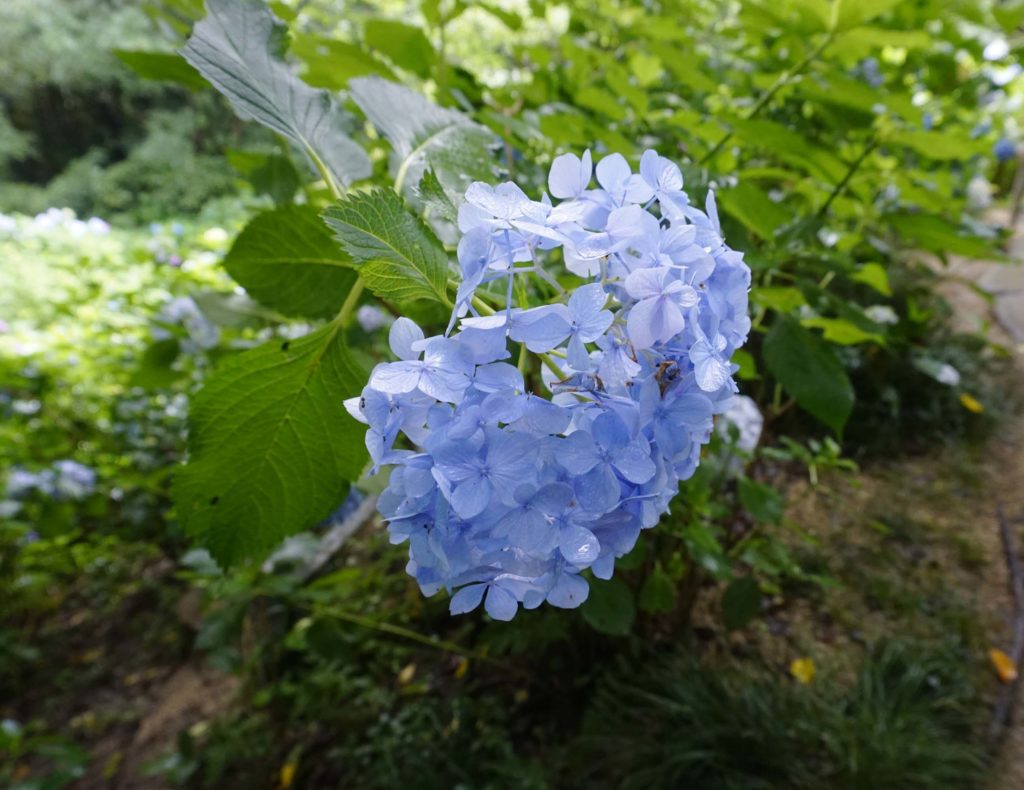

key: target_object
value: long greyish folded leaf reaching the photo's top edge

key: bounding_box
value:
[181,0,372,185]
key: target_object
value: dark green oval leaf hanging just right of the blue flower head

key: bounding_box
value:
[764,316,853,434]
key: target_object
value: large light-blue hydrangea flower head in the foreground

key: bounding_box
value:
[346,151,751,620]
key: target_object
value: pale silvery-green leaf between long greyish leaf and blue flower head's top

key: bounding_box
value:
[349,77,496,197]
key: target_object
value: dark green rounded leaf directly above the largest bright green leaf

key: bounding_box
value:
[224,206,357,319]
